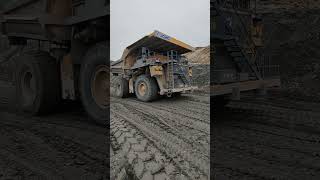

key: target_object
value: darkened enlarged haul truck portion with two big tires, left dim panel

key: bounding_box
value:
[0,0,110,123]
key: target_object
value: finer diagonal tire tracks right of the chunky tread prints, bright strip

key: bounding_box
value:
[111,95,210,179]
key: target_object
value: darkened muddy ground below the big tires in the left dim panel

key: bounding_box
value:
[0,82,109,180]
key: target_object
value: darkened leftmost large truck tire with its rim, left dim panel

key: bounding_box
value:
[14,51,61,116]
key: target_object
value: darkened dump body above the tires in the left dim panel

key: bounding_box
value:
[1,0,109,43]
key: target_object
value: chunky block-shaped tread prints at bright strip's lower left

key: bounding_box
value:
[110,113,185,180]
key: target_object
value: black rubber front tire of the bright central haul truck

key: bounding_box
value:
[134,75,159,102]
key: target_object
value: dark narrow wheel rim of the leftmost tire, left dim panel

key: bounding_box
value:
[20,70,36,106]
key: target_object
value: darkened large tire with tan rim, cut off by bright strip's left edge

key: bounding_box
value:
[79,43,110,125]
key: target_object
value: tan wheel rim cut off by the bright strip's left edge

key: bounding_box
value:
[91,65,109,109]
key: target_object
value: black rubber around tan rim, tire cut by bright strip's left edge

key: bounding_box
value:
[79,43,110,125]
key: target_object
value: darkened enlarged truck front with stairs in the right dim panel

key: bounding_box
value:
[210,0,280,106]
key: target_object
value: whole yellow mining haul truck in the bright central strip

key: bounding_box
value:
[111,31,197,102]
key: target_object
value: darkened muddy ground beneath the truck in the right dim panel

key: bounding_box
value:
[213,97,320,179]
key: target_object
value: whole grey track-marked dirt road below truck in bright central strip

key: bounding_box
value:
[111,95,210,179]
